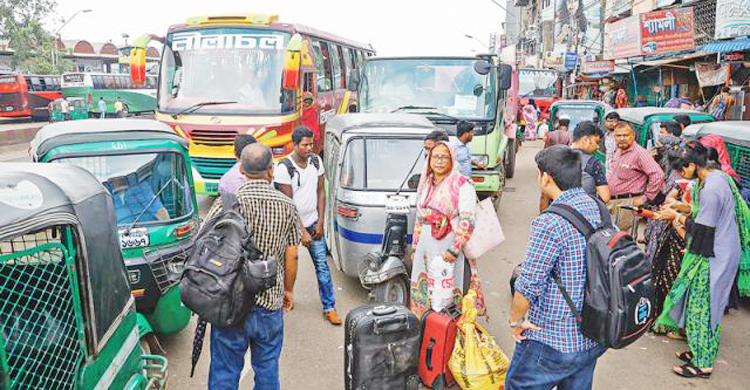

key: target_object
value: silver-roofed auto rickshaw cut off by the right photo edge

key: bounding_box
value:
[682,121,750,187]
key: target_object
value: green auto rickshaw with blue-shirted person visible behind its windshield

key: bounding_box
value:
[31,119,199,335]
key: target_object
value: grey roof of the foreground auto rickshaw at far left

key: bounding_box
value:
[0,163,114,230]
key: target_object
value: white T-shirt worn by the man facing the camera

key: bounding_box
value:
[273,156,325,227]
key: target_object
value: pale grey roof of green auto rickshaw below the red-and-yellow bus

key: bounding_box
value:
[30,118,187,160]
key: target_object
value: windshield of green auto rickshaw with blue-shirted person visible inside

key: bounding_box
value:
[54,152,193,225]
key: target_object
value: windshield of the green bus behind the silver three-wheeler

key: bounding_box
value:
[360,58,497,120]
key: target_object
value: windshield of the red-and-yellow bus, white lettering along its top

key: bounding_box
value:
[158,27,295,114]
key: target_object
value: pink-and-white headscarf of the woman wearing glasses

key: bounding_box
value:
[417,141,469,219]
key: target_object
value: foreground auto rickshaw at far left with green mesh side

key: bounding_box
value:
[0,163,167,390]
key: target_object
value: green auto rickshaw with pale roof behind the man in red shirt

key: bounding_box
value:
[615,107,714,149]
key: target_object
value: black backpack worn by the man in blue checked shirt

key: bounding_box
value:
[546,199,654,349]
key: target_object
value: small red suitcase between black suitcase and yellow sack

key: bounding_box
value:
[419,306,461,390]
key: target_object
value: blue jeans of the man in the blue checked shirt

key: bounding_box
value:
[505,340,606,390]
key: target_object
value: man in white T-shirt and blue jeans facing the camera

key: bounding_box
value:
[274,127,341,326]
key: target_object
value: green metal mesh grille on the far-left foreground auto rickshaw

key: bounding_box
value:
[0,227,84,390]
